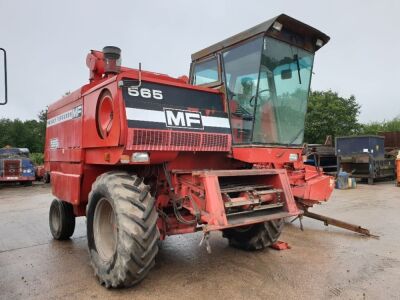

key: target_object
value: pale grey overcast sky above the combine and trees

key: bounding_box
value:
[0,0,400,122]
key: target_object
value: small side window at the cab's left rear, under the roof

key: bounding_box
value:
[192,57,220,85]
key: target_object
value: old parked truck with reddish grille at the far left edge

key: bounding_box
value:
[0,148,35,185]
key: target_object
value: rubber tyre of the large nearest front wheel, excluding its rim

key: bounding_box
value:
[87,171,160,288]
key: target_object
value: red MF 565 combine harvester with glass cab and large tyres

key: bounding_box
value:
[45,15,334,287]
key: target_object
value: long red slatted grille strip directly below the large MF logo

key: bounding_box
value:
[127,129,231,151]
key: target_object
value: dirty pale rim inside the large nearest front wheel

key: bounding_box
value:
[93,198,117,261]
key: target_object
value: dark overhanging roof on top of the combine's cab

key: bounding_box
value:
[192,14,330,62]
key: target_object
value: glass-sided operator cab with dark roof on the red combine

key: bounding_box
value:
[190,14,329,147]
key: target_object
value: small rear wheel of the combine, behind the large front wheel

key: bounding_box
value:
[49,199,75,240]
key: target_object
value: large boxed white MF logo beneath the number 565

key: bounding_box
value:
[164,108,204,130]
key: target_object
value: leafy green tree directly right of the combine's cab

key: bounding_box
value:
[304,90,361,144]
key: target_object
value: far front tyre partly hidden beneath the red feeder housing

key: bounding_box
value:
[223,219,284,251]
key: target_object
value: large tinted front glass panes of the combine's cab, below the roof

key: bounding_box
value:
[222,37,314,145]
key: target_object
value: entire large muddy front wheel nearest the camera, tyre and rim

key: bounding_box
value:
[86,172,160,288]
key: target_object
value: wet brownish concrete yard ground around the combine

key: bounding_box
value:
[0,183,400,300]
